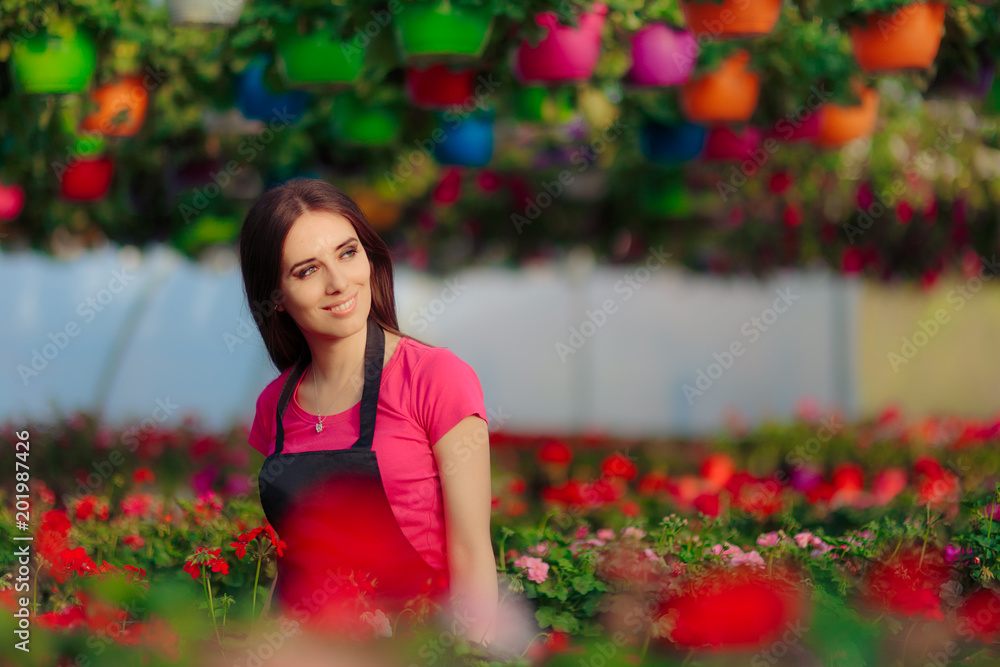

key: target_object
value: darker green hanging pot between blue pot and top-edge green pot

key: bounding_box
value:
[275,13,368,88]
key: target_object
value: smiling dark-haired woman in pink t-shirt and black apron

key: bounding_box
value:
[239,179,497,644]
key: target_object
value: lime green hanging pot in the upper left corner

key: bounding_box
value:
[11,30,97,94]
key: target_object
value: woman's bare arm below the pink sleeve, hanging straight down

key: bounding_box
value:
[434,416,498,643]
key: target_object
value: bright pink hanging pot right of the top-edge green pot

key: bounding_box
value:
[513,3,608,83]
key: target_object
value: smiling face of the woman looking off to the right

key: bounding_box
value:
[279,211,371,340]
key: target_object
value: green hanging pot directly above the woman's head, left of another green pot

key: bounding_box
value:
[276,26,365,86]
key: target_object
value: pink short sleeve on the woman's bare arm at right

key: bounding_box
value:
[410,347,489,447]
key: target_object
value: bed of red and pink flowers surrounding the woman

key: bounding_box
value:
[0,406,1000,665]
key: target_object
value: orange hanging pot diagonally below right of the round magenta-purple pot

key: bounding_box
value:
[681,50,760,123]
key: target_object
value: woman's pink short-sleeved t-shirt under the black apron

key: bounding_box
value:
[249,337,489,571]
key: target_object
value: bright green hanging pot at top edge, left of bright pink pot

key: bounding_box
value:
[394,0,493,63]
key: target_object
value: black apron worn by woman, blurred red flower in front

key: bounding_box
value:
[257,318,448,624]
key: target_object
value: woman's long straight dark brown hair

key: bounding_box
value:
[237,178,403,372]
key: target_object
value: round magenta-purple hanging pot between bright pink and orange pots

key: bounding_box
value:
[627,23,698,86]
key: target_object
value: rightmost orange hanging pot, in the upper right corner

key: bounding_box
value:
[851,2,947,72]
